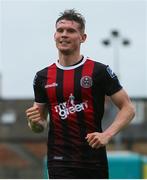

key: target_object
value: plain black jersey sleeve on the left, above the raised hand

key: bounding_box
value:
[33,73,47,103]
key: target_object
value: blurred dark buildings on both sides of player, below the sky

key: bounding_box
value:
[0,98,147,179]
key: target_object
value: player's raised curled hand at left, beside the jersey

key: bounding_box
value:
[26,106,42,123]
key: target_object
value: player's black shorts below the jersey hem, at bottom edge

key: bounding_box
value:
[48,167,109,179]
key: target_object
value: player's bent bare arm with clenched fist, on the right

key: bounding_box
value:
[86,90,135,148]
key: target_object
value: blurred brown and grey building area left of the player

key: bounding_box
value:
[0,99,47,179]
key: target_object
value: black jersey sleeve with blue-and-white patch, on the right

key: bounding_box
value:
[104,66,122,96]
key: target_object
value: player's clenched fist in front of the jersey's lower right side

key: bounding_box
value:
[86,132,109,149]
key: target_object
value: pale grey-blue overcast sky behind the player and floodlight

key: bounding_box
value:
[0,0,147,98]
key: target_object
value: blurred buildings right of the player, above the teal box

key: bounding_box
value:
[103,97,147,155]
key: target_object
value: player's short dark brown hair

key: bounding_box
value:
[56,9,86,32]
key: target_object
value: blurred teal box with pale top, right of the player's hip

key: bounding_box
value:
[108,151,142,179]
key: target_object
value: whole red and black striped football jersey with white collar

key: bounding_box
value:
[34,58,122,169]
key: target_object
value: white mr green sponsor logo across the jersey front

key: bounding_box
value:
[55,94,88,119]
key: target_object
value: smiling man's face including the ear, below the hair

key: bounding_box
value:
[54,20,86,54]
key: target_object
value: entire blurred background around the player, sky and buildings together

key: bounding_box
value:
[0,0,147,179]
